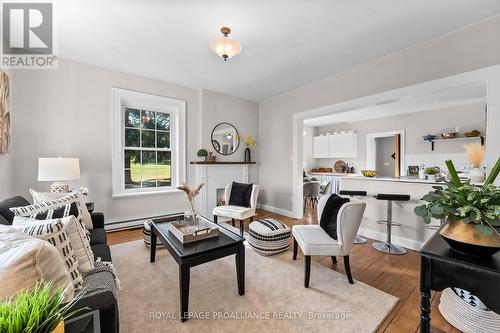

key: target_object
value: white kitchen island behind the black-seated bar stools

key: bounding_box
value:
[340,176,443,250]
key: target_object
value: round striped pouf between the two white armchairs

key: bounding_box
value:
[248,219,291,256]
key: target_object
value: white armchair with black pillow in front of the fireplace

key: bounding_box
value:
[213,184,259,236]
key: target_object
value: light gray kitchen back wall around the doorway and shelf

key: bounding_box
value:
[316,103,486,170]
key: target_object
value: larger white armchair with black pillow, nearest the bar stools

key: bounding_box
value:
[292,195,366,288]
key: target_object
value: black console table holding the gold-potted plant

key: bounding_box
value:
[420,233,500,333]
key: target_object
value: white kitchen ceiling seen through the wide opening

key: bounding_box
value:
[304,83,486,127]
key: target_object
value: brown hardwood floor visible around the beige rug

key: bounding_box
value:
[108,208,460,333]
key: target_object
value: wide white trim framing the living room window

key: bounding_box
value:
[111,88,186,197]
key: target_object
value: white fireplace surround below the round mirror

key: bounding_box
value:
[193,163,250,219]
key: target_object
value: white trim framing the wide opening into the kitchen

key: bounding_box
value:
[291,65,500,219]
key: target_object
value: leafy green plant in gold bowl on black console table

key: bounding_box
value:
[414,158,500,256]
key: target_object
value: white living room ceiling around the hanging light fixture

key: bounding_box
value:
[55,0,500,101]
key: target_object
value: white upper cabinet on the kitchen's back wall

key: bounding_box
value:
[313,133,358,158]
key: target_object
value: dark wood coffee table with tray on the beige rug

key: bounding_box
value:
[150,214,245,322]
